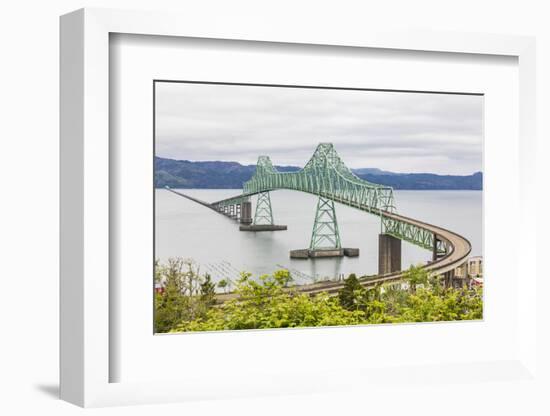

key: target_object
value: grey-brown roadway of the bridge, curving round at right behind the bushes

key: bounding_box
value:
[167,188,472,303]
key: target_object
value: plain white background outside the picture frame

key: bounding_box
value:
[0,0,550,415]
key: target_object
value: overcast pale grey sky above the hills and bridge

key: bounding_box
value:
[156,83,483,175]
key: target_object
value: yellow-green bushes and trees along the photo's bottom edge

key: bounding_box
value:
[155,259,483,332]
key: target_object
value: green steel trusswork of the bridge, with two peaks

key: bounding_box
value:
[212,143,449,255]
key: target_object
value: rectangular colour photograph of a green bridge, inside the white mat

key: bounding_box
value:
[151,80,484,333]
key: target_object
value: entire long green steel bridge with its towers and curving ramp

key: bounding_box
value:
[166,143,471,290]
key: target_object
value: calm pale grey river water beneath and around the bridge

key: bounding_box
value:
[155,189,483,282]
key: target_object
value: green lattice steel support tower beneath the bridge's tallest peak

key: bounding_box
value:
[309,196,342,250]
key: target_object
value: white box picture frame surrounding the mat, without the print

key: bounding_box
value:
[60,9,538,407]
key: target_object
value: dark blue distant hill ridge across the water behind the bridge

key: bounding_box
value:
[155,157,483,190]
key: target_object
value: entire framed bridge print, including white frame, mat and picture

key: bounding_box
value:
[61,9,537,406]
